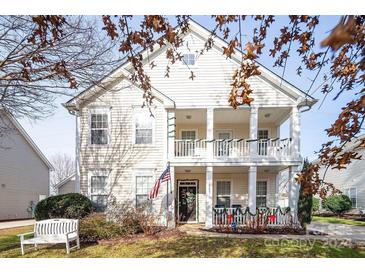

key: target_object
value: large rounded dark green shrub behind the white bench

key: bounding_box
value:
[34,193,92,221]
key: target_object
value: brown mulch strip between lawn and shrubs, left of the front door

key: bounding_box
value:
[98,229,187,245]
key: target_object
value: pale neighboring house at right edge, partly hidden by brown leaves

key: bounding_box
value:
[313,134,365,213]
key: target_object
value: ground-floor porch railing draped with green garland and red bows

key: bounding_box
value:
[213,208,298,228]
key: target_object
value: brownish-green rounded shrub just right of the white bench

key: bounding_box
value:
[80,213,125,243]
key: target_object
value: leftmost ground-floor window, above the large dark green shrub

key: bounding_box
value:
[90,175,108,211]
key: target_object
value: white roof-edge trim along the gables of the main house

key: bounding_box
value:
[63,19,318,110]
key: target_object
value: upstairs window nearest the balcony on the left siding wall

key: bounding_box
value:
[134,111,154,145]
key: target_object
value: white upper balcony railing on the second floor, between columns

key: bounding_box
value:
[175,138,291,159]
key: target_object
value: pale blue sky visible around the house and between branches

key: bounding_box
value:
[20,16,354,162]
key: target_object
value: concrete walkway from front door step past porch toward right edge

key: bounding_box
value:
[178,224,365,245]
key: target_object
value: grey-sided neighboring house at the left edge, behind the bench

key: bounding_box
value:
[0,110,52,220]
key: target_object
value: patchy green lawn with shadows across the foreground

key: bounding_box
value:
[0,225,365,258]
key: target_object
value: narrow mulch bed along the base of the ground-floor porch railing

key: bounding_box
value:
[201,227,306,235]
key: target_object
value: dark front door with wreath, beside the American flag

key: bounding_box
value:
[178,180,198,223]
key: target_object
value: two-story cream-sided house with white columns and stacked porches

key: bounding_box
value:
[64,21,316,227]
